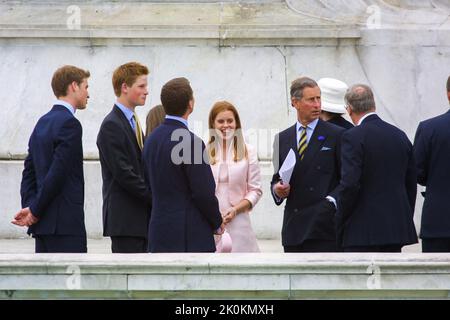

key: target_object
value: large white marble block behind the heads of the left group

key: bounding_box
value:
[0,45,287,159]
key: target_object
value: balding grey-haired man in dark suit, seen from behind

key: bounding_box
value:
[337,84,417,252]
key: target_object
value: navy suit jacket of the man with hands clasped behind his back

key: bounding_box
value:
[20,105,86,236]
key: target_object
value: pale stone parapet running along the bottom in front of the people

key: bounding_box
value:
[0,253,450,299]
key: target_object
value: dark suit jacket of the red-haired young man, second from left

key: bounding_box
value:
[97,106,151,238]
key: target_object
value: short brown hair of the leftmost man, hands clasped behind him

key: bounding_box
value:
[52,65,90,98]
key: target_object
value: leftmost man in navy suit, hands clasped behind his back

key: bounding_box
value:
[12,66,90,253]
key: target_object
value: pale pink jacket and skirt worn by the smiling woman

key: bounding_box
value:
[212,146,262,252]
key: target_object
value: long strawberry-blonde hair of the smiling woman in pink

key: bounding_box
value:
[207,101,248,165]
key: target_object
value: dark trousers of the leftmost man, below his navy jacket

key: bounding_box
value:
[34,234,87,253]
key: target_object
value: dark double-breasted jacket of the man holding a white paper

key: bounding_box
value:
[271,119,344,246]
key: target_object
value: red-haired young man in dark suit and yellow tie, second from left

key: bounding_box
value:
[97,62,151,253]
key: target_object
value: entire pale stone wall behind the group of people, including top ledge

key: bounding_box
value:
[0,0,450,238]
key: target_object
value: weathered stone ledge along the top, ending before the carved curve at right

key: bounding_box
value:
[0,1,360,43]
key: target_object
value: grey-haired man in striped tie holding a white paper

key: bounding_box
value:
[271,77,344,252]
